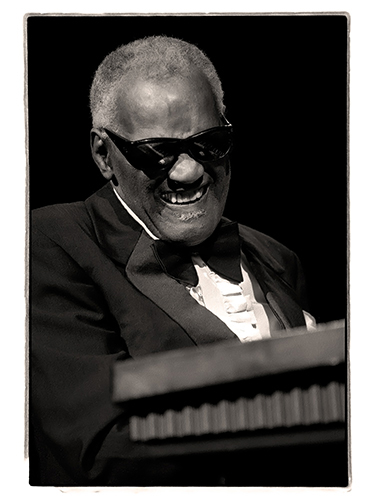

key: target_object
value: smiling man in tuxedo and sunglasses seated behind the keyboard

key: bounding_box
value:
[30,37,312,486]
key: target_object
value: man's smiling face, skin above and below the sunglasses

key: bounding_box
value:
[106,73,230,246]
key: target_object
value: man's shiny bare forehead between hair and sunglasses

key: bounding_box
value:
[116,71,219,140]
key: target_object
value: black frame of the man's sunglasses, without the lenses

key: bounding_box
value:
[103,115,233,172]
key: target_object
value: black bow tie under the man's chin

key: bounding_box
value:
[153,221,243,286]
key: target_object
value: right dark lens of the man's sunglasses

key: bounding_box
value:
[189,129,232,161]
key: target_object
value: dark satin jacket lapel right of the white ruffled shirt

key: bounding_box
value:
[243,241,305,328]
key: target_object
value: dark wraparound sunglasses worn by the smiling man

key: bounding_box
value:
[104,116,233,176]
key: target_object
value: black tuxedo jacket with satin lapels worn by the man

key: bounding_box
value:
[30,184,308,486]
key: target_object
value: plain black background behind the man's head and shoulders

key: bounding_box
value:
[27,15,348,322]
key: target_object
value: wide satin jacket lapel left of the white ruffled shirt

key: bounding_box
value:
[126,233,237,345]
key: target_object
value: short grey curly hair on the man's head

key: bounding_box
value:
[90,36,225,127]
